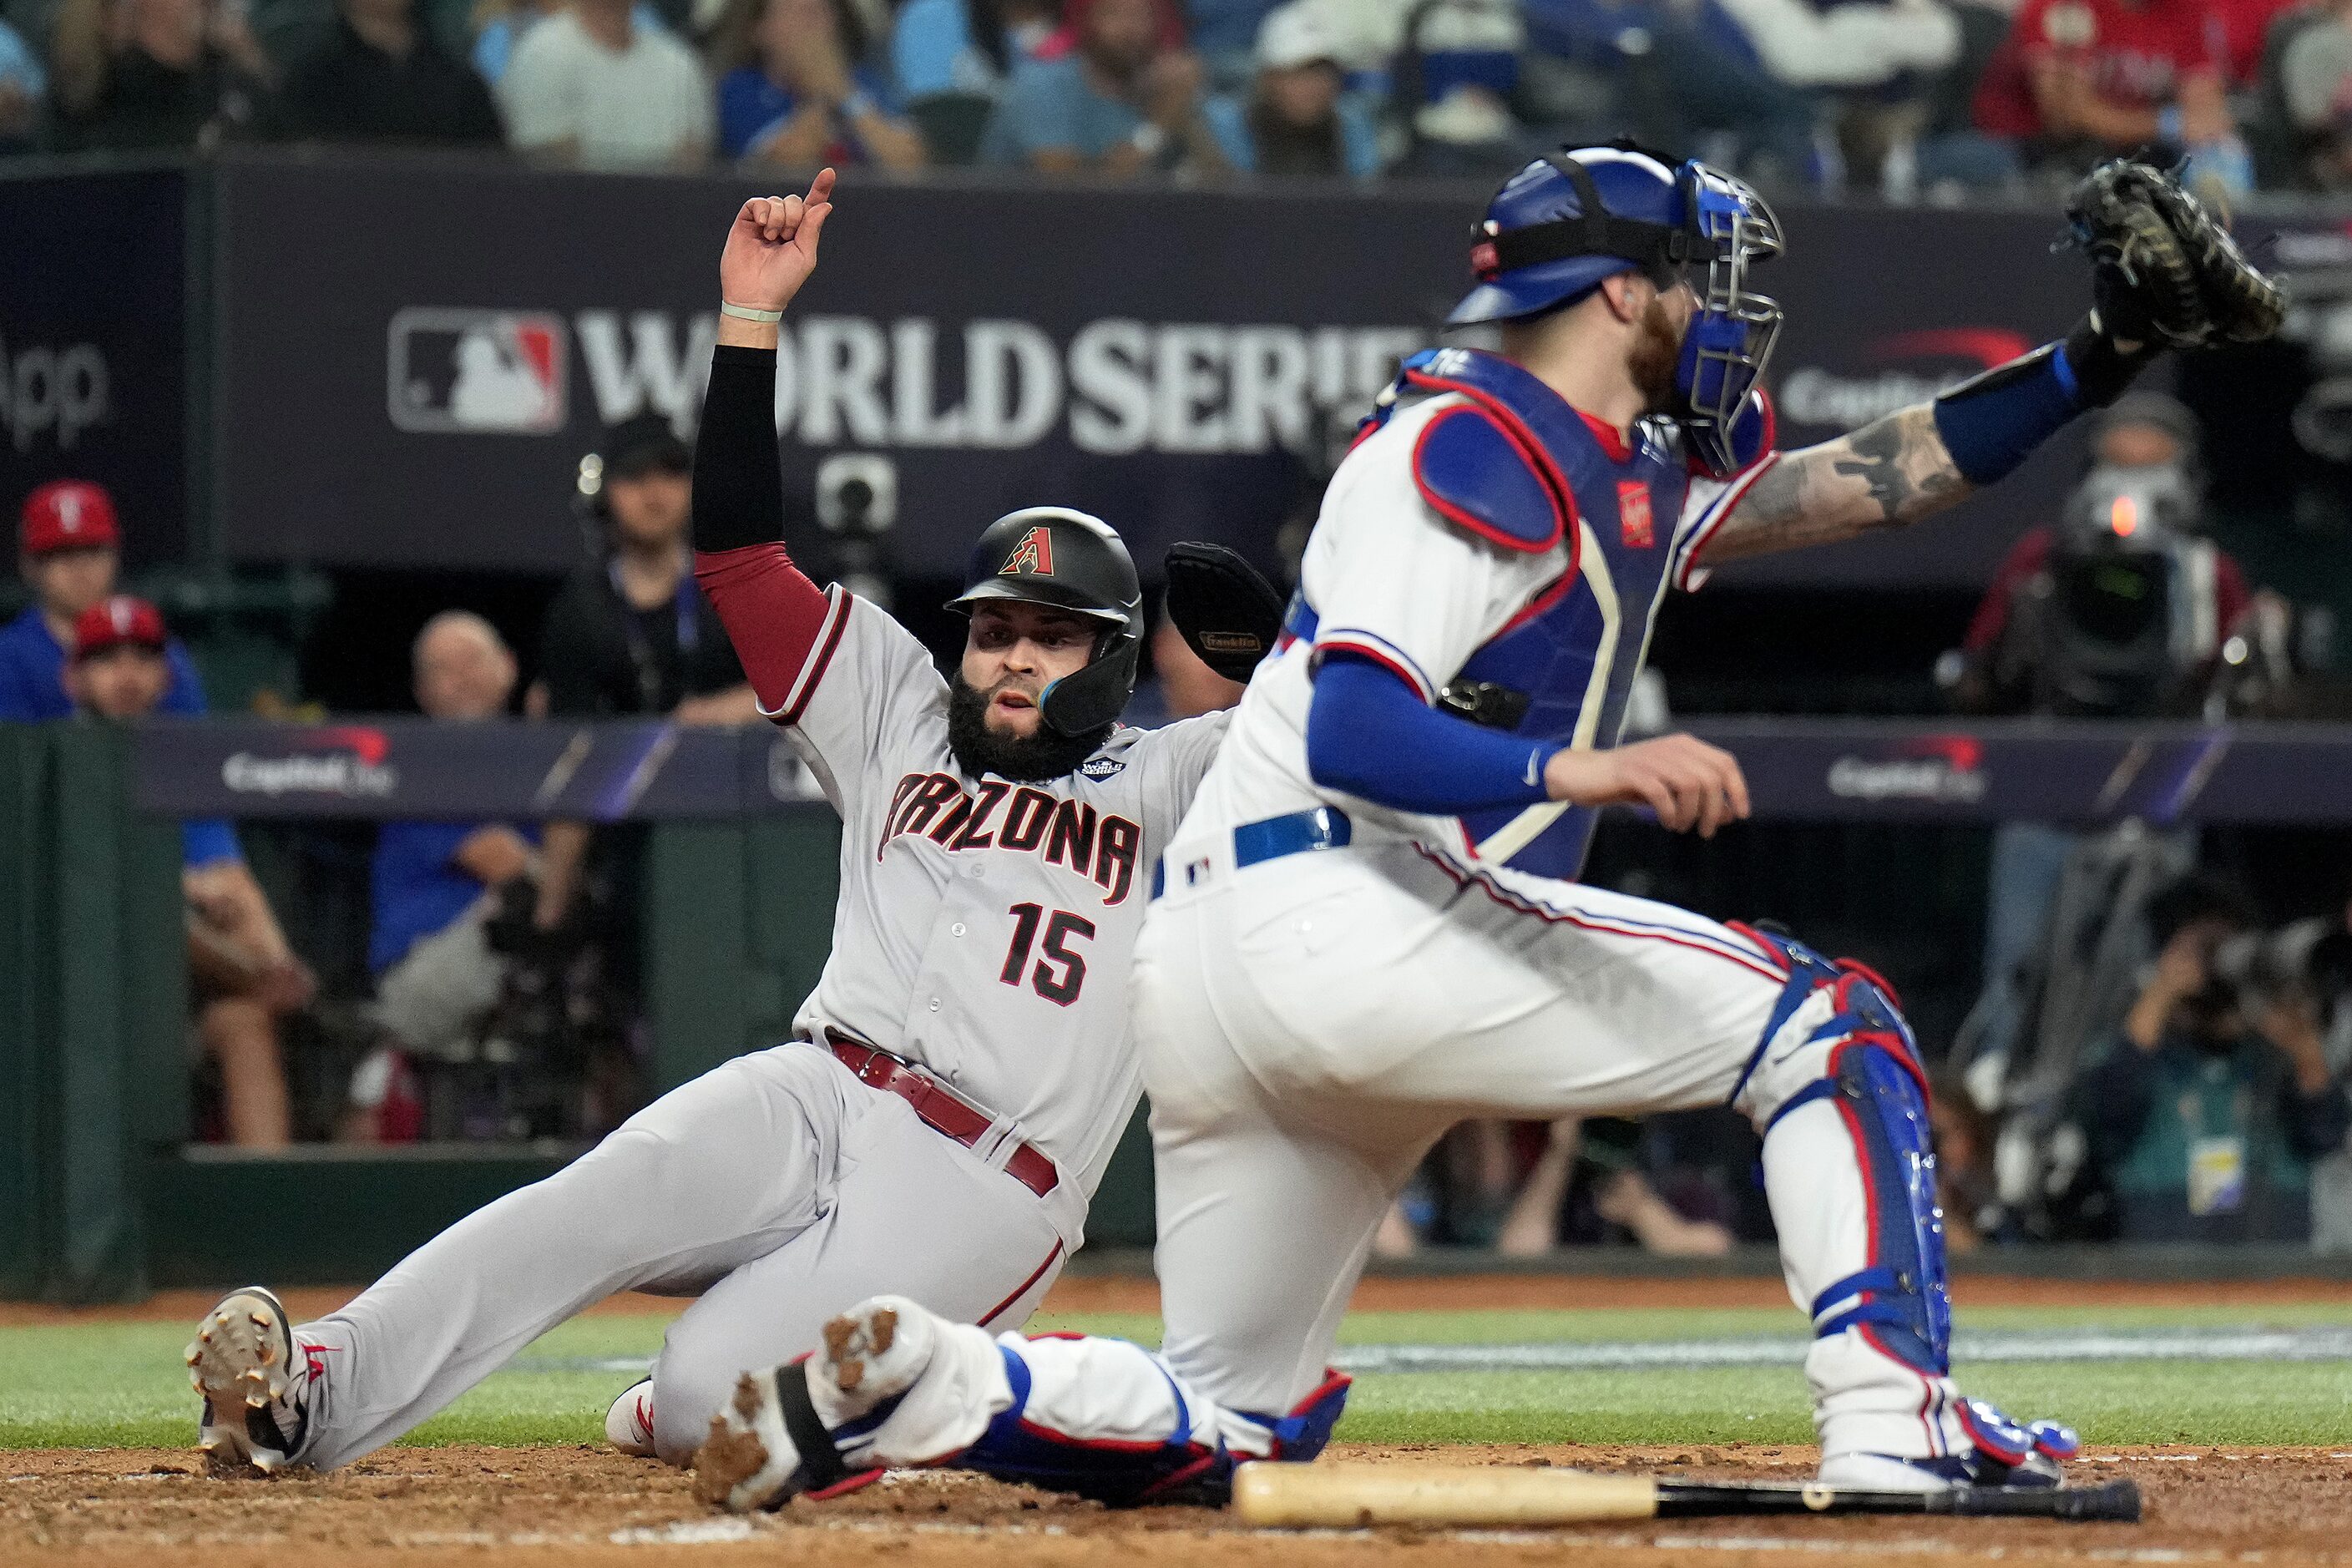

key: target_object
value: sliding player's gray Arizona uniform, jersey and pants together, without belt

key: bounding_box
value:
[282,574,1226,1469]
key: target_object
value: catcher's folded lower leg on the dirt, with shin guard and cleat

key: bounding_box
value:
[694,1295,1348,1511]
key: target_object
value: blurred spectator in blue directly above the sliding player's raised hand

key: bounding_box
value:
[715,0,924,169]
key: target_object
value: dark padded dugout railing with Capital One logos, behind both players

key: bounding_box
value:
[136,720,2352,822]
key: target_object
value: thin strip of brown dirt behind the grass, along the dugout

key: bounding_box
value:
[0,1274,2345,1328]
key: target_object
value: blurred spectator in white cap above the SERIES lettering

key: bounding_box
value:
[1204,0,1381,179]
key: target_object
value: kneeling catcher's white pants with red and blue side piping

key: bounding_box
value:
[1136,844,1964,1455]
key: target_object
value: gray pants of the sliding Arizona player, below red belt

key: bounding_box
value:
[296,1044,1085,1469]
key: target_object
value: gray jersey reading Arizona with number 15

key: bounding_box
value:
[765,588,1227,1194]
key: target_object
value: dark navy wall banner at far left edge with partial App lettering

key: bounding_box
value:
[0,169,188,564]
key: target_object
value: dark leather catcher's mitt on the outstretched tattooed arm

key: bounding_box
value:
[2065,158,2286,348]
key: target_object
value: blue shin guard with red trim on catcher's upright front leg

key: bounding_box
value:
[1733,931,1952,1378]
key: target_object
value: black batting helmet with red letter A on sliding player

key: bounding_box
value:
[948,505,1146,738]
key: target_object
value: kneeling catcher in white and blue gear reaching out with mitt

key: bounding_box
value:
[696,144,2279,1507]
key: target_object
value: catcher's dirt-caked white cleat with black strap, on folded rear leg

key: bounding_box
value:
[694,1295,936,1514]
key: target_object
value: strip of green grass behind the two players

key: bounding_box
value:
[18,1300,2352,1448]
